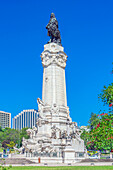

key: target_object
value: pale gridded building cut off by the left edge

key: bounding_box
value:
[0,111,11,129]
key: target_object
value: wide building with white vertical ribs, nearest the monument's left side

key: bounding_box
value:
[13,109,38,130]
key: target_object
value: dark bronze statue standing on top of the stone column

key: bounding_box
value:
[46,13,61,45]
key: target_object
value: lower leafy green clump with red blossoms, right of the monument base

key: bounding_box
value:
[81,113,113,151]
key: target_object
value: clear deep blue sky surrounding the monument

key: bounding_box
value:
[0,0,113,125]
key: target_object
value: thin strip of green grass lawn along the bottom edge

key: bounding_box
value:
[11,166,113,170]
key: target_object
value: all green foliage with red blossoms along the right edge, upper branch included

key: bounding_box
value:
[81,66,113,151]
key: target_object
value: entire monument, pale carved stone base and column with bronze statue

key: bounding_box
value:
[22,13,85,163]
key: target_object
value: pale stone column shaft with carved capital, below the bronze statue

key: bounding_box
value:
[41,43,69,121]
